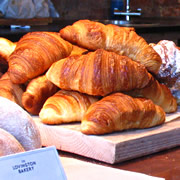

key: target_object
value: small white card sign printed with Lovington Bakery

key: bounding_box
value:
[0,146,67,180]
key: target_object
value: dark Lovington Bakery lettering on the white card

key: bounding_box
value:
[12,160,36,174]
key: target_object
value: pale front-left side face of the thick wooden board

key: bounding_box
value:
[36,122,115,164]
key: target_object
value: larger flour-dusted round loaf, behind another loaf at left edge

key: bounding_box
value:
[0,97,41,150]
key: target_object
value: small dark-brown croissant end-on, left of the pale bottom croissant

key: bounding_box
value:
[22,75,58,115]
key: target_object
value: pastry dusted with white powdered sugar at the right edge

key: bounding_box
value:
[150,40,180,105]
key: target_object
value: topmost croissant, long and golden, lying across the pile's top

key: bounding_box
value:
[59,20,162,74]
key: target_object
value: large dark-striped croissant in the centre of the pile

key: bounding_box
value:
[46,49,151,96]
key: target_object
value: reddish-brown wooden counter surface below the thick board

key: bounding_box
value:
[59,147,180,180]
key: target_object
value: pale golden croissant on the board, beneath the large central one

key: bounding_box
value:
[39,90,98,124]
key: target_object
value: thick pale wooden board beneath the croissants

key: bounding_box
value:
[33,108,180,164]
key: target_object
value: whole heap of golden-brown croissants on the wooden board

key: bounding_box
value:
[0,20,177,135]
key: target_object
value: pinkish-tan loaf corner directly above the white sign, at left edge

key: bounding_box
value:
[0,128,25,156]
